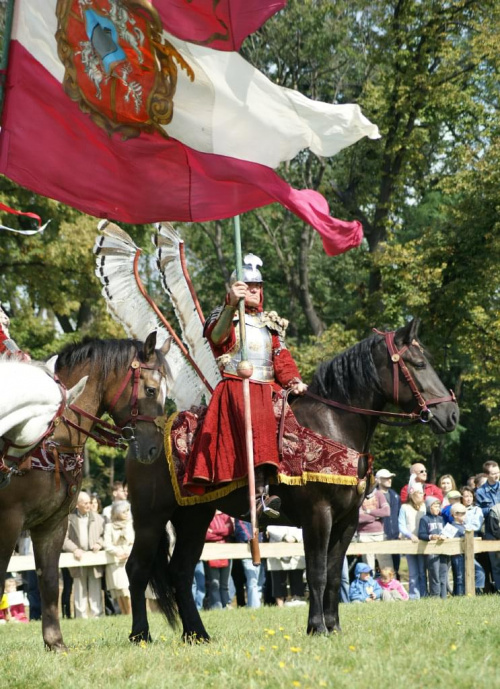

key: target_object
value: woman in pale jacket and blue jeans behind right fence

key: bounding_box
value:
[398,490,427,599]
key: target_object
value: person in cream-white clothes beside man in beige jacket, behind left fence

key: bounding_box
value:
[104,500,135,615]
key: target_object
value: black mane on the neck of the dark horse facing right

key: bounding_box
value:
[309,335,381,404]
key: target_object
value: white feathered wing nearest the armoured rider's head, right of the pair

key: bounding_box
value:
[153,223,221,388]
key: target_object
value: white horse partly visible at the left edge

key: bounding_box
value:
[0,357,87,457]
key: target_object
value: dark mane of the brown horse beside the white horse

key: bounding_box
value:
[56,337,144,383]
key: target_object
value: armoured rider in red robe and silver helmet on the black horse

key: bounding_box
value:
[184,254,307,519]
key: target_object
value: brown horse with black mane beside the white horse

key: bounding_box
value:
[0,333,169,650]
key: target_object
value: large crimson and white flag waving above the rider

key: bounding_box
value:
[0,0,379,255]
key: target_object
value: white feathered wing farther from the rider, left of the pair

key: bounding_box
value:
[94,221,209,410]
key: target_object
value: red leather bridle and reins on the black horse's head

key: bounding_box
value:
[305,328,457,425]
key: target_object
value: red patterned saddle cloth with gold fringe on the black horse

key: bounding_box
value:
[165,403,362,506]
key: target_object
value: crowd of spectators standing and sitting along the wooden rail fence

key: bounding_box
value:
[0,461,500,624]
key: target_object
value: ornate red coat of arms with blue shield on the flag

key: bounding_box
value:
[56,0,194,139]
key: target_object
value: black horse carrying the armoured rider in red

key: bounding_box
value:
[127,321,459,641]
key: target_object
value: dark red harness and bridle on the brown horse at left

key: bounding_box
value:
[0,359,165,496]
